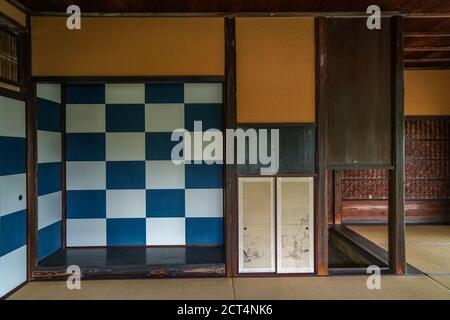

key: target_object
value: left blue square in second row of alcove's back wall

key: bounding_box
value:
[106,104,145,132]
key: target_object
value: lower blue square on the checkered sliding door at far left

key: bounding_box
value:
[0,210,27,257]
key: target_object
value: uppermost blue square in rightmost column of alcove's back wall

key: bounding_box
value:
[184,103,223,132]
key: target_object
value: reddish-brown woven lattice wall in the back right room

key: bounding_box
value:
[342,118,450,200]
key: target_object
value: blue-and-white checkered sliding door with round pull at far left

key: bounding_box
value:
[0,97,27,297]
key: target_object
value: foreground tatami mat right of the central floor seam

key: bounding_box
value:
[235,276,450,300]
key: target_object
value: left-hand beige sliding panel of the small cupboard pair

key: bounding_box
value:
[239,178,275,273]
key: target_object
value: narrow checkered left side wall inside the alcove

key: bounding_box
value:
[37,84,62,260]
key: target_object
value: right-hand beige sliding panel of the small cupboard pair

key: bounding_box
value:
[277,177,314,273]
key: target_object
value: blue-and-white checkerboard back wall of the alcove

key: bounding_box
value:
[66,83,223,247]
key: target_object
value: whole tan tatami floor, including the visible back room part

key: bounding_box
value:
[10,226,450,300]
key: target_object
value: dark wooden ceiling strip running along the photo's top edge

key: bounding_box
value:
[13,0,450,14]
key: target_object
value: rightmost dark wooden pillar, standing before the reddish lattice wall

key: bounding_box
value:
[388,16,406,274]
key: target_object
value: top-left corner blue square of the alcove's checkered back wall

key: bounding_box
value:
[66,84,105,104]
